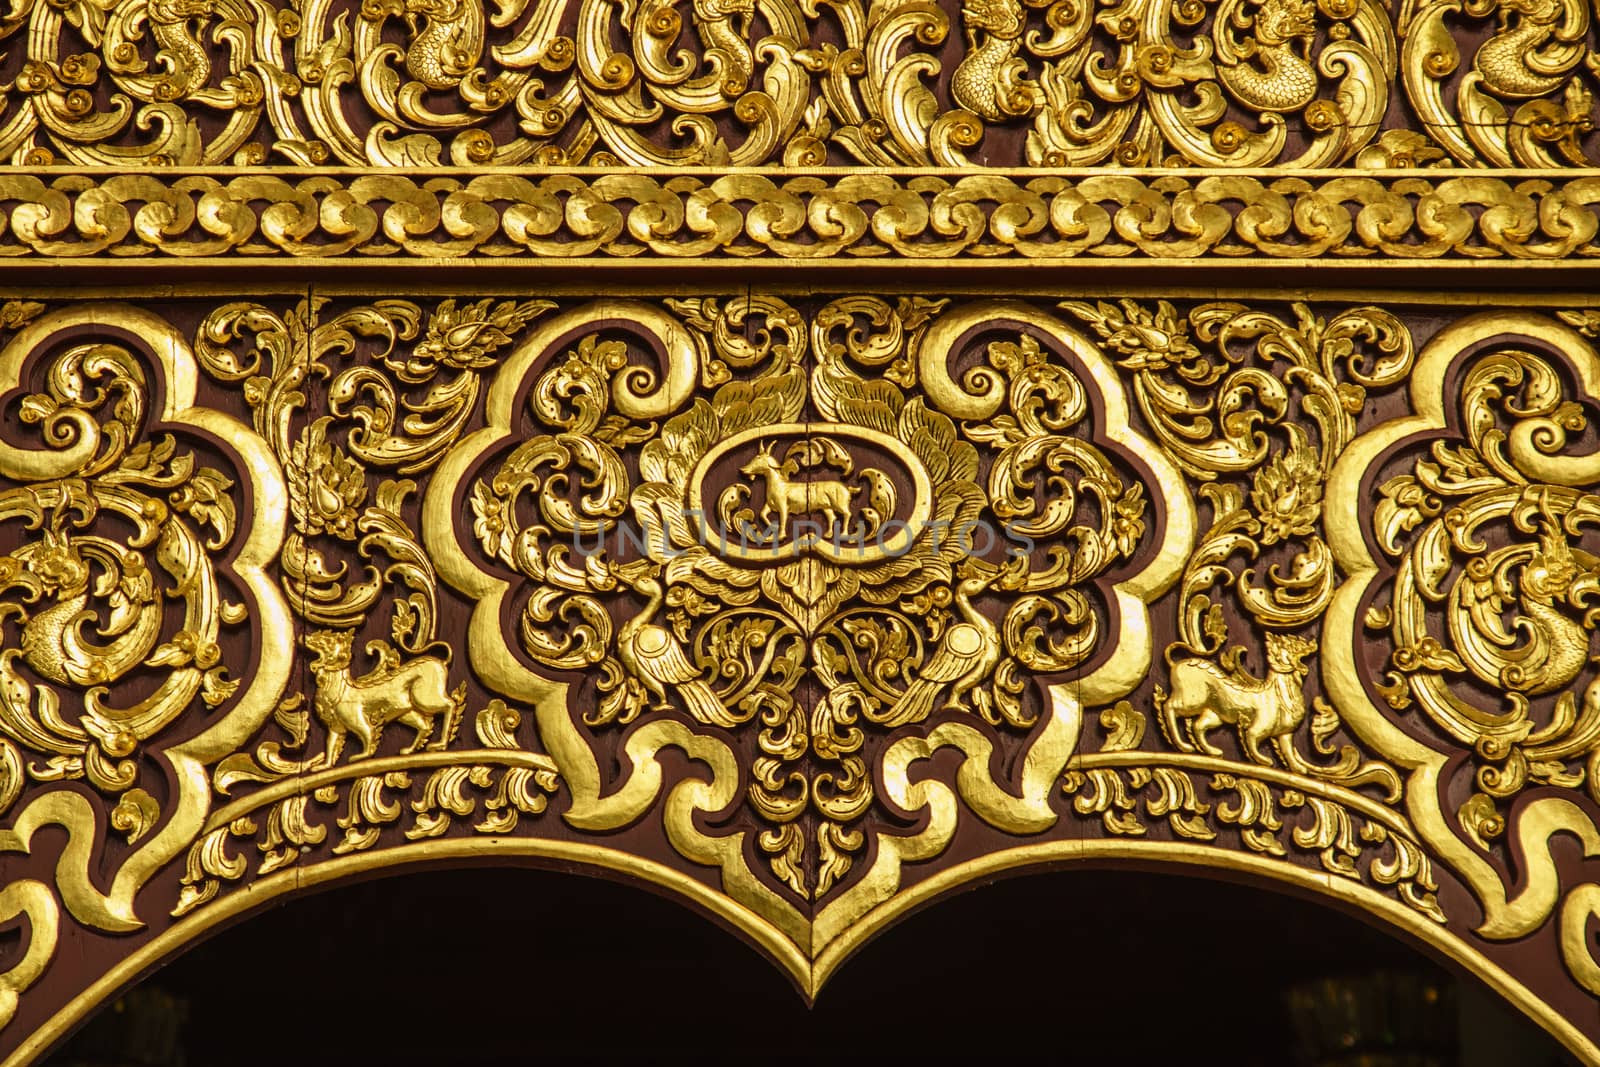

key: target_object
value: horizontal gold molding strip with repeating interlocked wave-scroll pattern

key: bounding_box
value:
[9,168,1600,270]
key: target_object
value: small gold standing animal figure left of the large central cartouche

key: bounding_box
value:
[306,630,467,766]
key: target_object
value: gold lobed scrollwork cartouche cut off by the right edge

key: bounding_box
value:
[1328,312,1600,1011]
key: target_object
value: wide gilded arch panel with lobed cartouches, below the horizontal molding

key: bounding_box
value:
[0,287,1600,1064]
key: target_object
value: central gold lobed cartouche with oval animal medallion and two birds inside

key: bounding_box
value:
[426,296,1189,929]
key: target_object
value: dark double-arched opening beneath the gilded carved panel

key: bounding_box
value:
[45,869,1574,1067]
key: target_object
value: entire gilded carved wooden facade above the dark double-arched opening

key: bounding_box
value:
[0,0,1600,1065]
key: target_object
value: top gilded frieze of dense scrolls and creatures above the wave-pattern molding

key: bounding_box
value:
[0,0,1600,168]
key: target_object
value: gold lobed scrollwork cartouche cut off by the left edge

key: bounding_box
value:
[0,301,291,1022]
